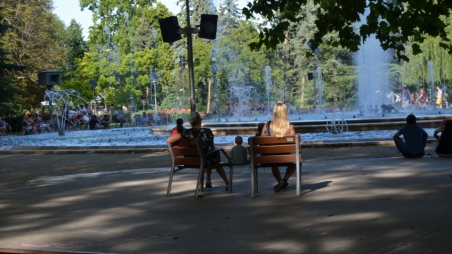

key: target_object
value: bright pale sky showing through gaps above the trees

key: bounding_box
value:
[53,0,249,40]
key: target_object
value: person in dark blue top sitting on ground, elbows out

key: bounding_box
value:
[393,114,428,158]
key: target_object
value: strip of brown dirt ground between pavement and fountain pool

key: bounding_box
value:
[0,144,436,187]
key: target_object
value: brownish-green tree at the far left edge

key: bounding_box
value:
[0,0,64,109]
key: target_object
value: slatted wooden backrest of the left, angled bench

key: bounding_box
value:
[168,138,206,168]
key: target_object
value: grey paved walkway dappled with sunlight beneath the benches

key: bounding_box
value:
[0,158,452,254]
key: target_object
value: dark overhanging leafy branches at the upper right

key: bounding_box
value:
[242,0,452,60]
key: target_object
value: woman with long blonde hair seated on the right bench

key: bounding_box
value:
[261,102,296,192]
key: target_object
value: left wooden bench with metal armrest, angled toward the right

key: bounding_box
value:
[166,138,234,198]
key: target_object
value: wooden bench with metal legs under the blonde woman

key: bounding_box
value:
[248,134,301,197]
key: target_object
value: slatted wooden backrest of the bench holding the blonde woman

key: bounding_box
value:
[248,134,302,166]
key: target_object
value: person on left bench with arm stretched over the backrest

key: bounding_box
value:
[166,112,229,191]
